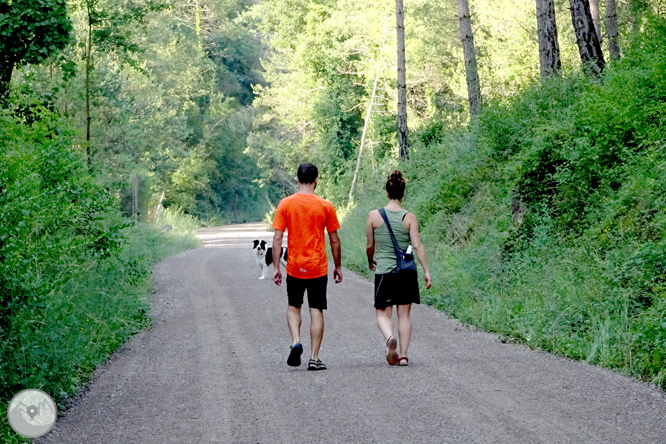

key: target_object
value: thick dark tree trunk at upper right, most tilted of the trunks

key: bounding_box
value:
[569,0,606,75]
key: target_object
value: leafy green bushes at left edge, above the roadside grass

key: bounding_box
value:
[0,111,123,332]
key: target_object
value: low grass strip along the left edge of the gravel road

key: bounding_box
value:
[0,219,199,443]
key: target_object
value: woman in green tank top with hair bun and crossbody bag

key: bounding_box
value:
[365,170,432,366]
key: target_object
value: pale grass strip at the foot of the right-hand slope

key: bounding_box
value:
[340,179,666,388]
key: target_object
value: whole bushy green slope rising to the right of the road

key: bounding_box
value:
[341,14,666,388]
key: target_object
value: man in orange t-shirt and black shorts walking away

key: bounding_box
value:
[273,163,342,370]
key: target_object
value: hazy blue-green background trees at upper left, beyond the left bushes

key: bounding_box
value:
[44,0,269,221]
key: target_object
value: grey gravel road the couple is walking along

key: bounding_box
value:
[39,224,666,444]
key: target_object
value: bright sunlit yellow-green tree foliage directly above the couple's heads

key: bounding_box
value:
[248,0,464,204]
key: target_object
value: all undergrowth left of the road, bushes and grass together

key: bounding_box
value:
[0,104,197,442]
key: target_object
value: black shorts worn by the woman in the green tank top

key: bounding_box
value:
[375,270,421,310]
